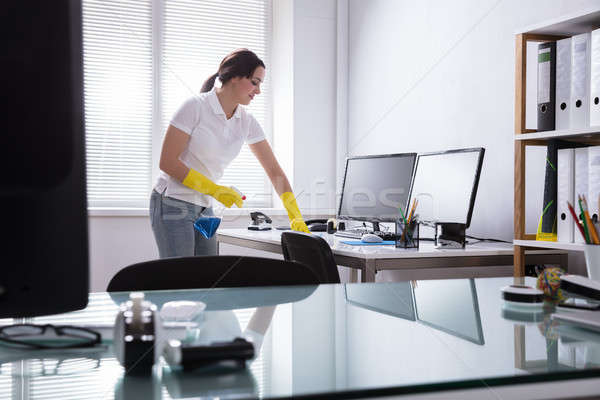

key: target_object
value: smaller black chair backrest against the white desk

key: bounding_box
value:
[281,232,340,283]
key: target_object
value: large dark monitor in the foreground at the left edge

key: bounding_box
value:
[0,0,89,318]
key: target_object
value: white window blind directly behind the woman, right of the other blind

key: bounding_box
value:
[160,0,271,207]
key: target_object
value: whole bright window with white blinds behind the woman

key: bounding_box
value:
[83,0,271,208]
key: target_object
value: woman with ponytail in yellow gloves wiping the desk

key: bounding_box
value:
[150,49,309,258]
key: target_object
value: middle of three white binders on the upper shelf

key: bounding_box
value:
[569,33,591,128]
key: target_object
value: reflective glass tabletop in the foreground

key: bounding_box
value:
[0,278,600,399]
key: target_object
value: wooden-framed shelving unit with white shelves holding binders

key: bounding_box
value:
[513,8,600,277]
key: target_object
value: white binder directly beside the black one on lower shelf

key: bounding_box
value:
[556,149,576,243]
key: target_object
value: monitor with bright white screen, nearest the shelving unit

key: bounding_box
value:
[410,147,485,228]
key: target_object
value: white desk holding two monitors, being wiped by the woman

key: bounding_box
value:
[217,229,568,282]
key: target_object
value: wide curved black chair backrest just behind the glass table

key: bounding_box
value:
[106,256,319,292]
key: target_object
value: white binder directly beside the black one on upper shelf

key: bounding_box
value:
[555,38,571,130]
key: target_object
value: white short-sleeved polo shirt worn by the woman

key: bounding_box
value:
[154,88,265,207]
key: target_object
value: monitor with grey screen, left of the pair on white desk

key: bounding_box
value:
[338,153,417,222]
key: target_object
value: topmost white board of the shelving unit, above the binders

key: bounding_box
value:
[515,7,600,36]
